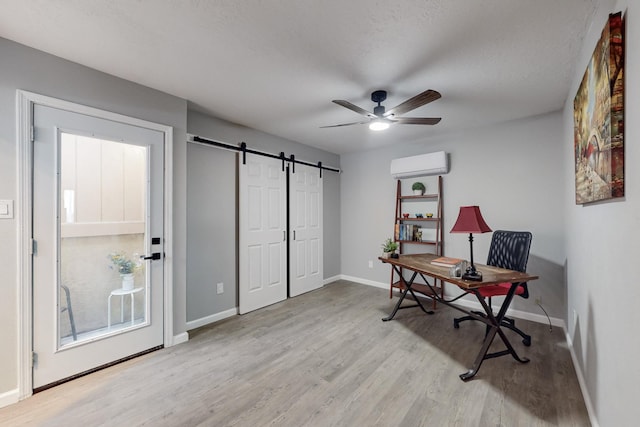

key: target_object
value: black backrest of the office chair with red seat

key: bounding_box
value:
[487,230,532,298]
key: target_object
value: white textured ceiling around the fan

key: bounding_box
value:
[0,0,595,153]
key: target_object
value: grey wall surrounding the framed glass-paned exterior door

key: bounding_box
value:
[0,38,187,406]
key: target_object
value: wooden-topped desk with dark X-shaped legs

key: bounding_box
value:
[378,254,538,381]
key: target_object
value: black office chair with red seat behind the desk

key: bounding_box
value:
[453,230,531,347]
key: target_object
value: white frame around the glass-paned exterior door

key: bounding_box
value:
[16,90,174,400]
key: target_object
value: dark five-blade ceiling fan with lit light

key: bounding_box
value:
[320,89,442,130]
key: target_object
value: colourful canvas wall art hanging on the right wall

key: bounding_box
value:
[573,12,625,204]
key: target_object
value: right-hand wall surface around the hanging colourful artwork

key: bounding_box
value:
[562,0,640,426]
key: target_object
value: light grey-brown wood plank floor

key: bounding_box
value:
[0,281,589,427]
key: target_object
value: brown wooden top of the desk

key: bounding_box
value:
[378,254,538,289]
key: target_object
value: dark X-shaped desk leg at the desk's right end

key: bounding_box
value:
[460,284,529,381]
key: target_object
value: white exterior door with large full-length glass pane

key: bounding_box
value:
[32,104,164,388]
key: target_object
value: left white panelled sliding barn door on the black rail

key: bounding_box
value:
[238,154,287,314]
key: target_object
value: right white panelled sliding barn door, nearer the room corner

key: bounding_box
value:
[289,165,322,297]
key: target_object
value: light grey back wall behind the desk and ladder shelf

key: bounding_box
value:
[341,112,565,318]
